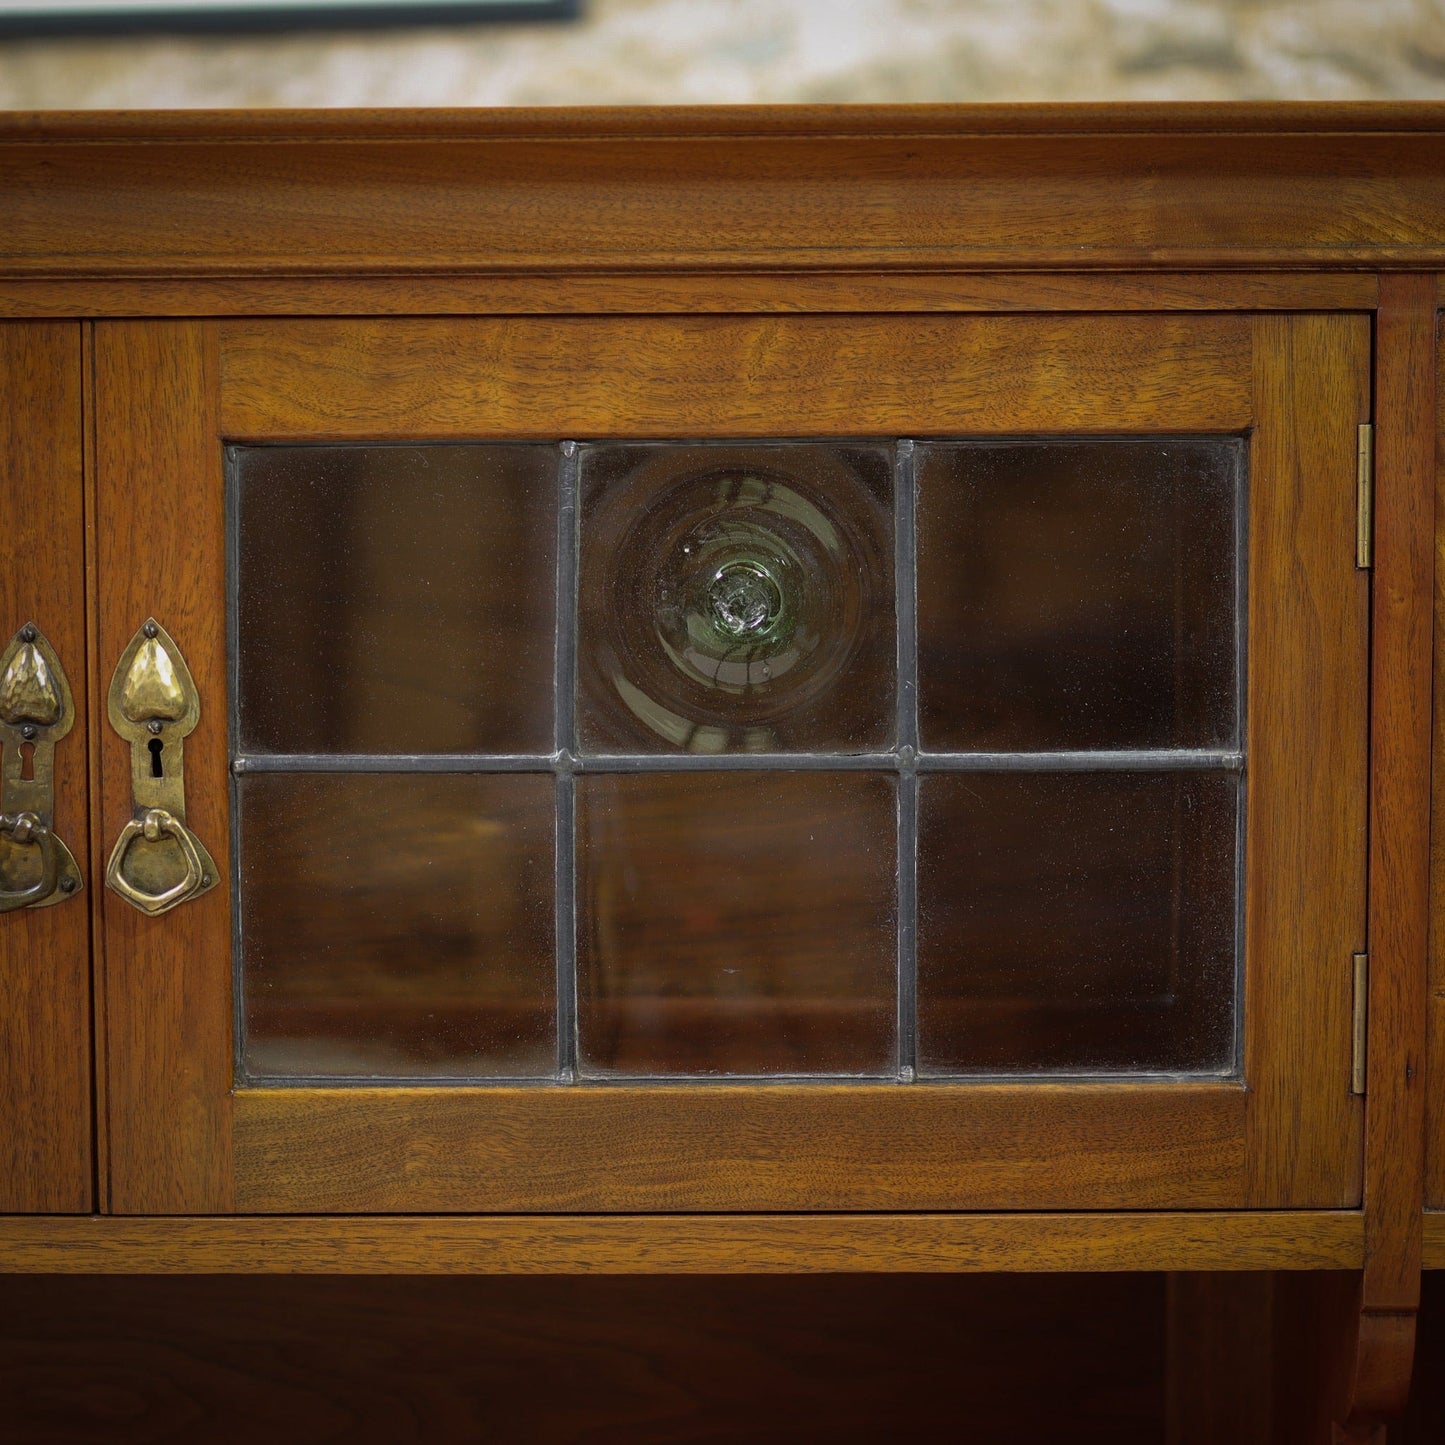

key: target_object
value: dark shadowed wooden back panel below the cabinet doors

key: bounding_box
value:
[0,1274,1161,1445]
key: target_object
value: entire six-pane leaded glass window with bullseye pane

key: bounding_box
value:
[227,436,1246,1087]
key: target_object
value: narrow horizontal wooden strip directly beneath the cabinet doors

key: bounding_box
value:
[0,1211,1358,1274]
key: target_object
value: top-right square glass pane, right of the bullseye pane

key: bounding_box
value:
[918,438,1243,751]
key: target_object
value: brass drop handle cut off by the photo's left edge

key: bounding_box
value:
[0,623,84,913]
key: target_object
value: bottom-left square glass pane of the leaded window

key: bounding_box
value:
[237,773,556,1078]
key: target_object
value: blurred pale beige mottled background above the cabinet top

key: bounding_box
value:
[0,0,1445,108]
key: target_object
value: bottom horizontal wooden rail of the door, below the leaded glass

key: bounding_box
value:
[234,1084,1248,1214]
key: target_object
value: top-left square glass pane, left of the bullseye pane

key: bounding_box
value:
[234,445,558,753]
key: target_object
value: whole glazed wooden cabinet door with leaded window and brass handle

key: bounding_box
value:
[95,315,1370,1212]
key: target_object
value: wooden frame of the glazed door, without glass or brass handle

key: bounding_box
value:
[95,314,1370,1214]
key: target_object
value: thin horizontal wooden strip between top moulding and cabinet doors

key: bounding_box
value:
[0,269,1379,316]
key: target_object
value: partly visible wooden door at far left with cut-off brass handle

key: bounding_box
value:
[0,321,92,1214]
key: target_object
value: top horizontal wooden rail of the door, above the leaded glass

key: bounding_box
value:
[221,315,1251,438]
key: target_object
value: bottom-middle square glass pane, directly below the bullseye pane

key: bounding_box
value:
[577,773,897,1074]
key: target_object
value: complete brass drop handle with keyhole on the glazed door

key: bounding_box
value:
[105,617,217,916]
